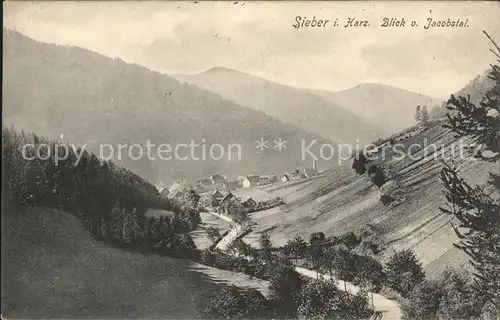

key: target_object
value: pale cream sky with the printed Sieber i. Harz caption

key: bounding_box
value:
[3,1,500,98]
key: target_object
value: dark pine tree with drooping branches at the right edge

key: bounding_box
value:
[440,32,500,313]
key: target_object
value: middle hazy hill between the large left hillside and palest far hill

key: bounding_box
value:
[175,67,387,143]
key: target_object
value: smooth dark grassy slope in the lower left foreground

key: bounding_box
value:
[2,208,225,319]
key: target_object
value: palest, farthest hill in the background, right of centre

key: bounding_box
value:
[312,83,441,133]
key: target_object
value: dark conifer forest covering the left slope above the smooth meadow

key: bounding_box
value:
[2,128,200,254]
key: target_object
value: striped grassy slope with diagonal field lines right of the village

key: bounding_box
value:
[244,121,499,274]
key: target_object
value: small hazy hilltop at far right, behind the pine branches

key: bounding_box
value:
[430,69,494,118]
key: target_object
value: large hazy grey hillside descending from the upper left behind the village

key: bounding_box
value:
[3,30,328,184]
